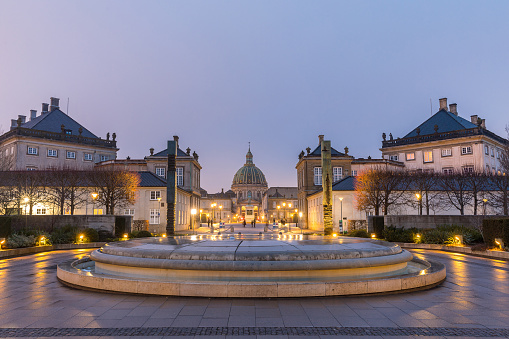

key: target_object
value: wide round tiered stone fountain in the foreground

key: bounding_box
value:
[57,235,445,298]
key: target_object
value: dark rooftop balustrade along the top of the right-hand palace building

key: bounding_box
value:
[382,127,508,148]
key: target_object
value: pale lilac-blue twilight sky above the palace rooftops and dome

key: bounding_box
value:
[0,0,509,192]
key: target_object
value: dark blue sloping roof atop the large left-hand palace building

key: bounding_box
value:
[21,109,97,138]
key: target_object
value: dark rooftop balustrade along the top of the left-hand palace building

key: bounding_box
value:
[0,127,117,148]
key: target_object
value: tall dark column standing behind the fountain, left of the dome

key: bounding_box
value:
[166,140,177,236]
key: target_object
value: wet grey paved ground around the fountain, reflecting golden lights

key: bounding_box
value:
[0,246,509,338]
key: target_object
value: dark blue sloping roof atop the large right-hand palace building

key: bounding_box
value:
[404,109,478,138]
